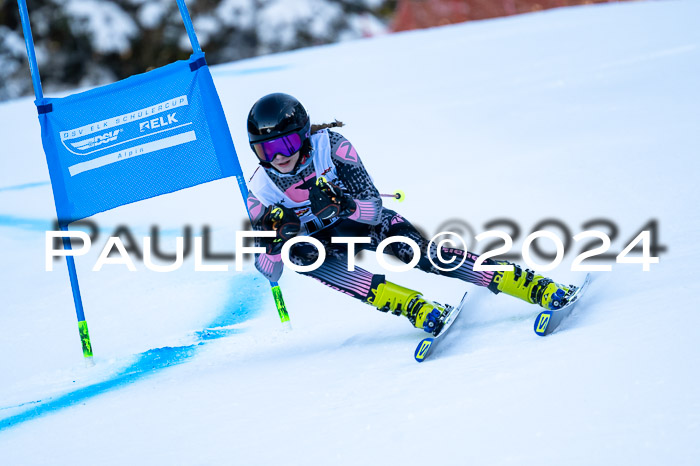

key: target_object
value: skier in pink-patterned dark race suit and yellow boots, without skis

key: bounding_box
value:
[247,93,576,334]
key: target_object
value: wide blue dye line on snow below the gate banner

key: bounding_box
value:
[0,275,265,431]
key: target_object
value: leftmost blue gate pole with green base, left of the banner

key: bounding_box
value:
[17,0,94,365]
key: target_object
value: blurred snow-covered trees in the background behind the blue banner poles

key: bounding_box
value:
[0,0,395,100]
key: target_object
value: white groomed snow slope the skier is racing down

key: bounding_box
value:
[0,0,700,465]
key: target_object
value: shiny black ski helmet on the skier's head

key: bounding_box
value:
[248,92,311,152]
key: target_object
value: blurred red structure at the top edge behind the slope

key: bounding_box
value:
[391,0,618,32]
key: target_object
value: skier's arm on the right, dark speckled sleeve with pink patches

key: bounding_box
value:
[328,131,382,225]
